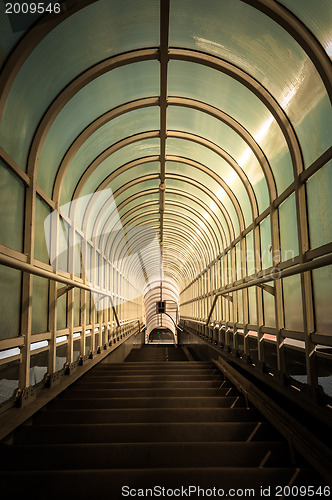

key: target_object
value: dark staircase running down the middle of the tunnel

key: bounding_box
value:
[0,346,322,500]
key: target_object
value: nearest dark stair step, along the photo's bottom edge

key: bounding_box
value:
[0,467,308,500]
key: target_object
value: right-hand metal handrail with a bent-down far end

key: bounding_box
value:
[206,254,332,325]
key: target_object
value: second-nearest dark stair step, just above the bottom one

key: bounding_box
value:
[0,441,290,470]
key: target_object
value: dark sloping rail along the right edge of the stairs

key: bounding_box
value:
[212,357,332,484]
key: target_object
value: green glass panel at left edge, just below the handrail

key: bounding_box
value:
[0,265,22,339]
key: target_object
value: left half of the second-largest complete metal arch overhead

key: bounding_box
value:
[52,97,160,202]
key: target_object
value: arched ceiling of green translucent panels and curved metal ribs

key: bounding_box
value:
[0,0,332,296]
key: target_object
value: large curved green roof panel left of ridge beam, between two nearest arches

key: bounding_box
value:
[0,0,159,168]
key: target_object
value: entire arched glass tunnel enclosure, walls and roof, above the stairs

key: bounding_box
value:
[0,0,332,416]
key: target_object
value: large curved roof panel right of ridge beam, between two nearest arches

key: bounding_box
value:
[170,0,332,170]
